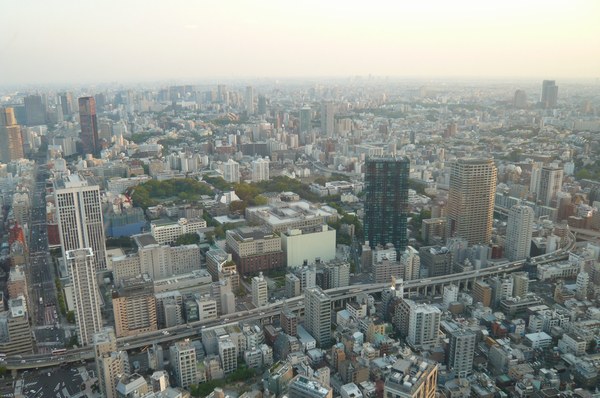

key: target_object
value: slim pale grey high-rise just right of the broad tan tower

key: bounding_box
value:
[504,205,535,261]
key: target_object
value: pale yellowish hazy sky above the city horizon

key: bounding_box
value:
[0,0,600,85]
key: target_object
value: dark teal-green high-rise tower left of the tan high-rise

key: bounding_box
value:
[364,157,410,253]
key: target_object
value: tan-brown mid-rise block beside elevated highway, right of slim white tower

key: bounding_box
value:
[112,275,158,337]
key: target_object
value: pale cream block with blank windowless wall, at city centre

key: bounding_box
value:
[281,224,336,268]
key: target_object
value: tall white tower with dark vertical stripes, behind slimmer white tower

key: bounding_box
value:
[54,174,106,270]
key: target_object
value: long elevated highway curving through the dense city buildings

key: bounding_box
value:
[5,233,575,370]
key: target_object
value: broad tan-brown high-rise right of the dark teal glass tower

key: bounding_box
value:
[446,159,497,245]
